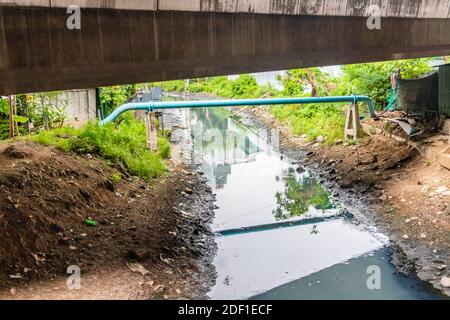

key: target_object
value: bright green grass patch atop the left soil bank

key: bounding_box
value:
[31,114,170,180]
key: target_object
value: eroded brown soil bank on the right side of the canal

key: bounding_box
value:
[246,108,450,295]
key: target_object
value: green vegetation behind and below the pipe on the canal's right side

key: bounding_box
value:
[154,59,432,144]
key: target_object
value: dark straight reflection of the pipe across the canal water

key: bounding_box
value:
[215,213,342,236]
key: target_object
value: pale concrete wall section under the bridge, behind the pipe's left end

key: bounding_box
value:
[61,89,97,127]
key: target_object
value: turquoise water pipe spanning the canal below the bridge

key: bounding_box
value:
[100,95,377,125]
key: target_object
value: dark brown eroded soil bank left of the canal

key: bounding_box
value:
[0,142,215,299]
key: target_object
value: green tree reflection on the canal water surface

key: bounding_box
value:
[273,167,336,221]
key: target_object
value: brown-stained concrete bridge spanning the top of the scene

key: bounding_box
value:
[0,0,450,95]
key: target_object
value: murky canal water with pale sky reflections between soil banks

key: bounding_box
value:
[166,104,443,299]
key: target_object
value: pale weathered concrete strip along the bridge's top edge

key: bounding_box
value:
[0,0,450,18]
